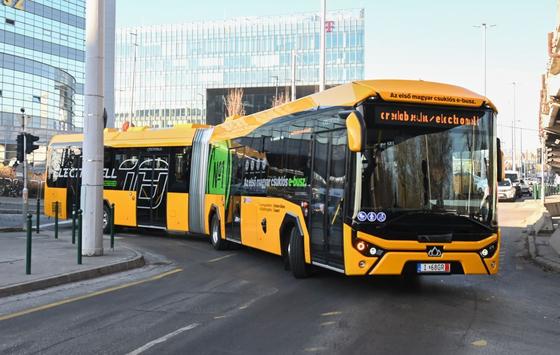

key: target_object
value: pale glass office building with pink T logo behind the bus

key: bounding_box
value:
[115,9,364,127]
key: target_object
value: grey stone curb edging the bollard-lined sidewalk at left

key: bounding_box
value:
[0,249,146,298]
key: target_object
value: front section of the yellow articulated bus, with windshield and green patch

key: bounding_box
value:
[203,80,502,277]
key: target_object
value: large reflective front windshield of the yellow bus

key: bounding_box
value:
[355,110,496,238]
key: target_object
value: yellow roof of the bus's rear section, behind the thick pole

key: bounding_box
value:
[50,124,209,148]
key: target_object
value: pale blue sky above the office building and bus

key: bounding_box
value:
[117,0,557,150]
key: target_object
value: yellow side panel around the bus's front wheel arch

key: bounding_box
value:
[241,196,311,263]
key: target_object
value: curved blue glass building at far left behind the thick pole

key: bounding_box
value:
[0,0,85,163]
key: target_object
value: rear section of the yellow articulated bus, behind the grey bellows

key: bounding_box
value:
[45,125,207,232]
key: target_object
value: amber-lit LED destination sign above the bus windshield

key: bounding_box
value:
[374,106,484,128]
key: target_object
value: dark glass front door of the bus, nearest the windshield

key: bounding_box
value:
[310,131,346,271]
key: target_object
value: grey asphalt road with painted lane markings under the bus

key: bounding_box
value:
[0,203,560,355]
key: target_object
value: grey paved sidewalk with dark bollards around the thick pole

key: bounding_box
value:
[0,228,144,297]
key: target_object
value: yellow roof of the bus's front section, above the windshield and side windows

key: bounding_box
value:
[213,80,497,140]
